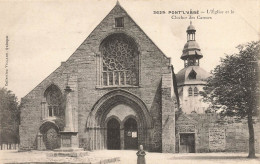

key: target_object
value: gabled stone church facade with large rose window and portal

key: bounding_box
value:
[20,3,178,152]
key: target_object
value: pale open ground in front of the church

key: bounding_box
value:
[0,150,260,164]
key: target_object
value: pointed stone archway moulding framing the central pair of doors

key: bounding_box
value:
[87,90,152,149]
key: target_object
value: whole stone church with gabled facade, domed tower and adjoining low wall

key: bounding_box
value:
[19,3,258,153]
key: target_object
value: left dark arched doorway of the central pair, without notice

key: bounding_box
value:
[107,118,120,150]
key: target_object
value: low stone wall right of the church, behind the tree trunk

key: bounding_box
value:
[176,114,260,153]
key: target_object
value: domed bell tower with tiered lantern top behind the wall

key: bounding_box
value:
[176,22,210,114]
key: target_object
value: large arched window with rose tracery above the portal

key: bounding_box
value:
[101,34,139,86]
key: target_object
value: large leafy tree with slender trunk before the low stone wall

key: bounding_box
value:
[202,41,260,158]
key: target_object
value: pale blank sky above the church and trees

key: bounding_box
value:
[0,0,260,99]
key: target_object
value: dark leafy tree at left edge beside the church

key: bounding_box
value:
[0,88,20,143]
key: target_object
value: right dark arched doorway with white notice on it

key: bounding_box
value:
[124,118,138,149]
